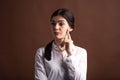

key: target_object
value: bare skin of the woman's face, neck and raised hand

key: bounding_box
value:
[51,16,73,56]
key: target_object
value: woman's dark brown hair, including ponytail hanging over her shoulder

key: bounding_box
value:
[44,8,75,60]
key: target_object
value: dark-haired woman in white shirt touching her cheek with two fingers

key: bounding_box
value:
[35,8,87,80]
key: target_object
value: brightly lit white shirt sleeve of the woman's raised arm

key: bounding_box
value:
[65,48,87,80]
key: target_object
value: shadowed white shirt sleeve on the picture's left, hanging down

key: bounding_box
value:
[35,48,48,80]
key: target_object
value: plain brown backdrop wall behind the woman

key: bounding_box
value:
[0,0,120,80]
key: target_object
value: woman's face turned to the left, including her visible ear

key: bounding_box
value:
[51,16,72,39]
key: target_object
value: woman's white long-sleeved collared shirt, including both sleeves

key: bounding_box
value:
[35,43,87,80]
